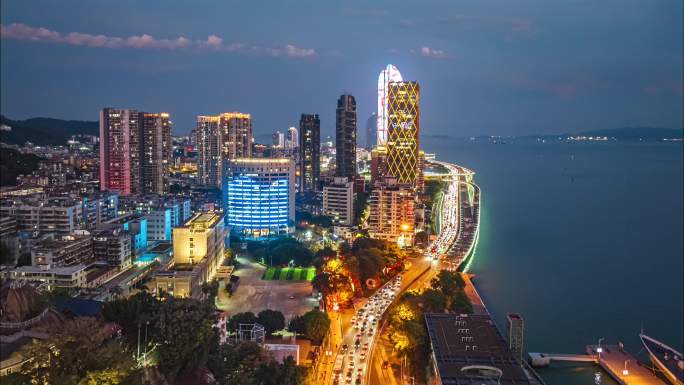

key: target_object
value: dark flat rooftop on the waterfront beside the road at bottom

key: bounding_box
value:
[425,313,536,385]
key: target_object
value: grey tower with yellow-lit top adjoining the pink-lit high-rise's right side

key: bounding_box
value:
[140,113,172,194]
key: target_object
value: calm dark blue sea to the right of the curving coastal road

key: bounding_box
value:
[421,137,684,385]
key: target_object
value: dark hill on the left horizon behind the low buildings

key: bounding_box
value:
[0,115,100,145]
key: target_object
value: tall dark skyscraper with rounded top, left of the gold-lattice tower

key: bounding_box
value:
[335,94,356,180]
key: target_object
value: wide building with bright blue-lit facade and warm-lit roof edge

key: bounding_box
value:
[222,158,295,238]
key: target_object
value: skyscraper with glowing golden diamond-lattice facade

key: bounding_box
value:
[387,82,420,187]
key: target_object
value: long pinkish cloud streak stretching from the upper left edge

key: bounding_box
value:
[0,23,316,58]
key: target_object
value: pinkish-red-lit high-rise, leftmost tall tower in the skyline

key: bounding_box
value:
[100,108,141,195]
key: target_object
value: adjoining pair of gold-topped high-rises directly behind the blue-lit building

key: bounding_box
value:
[195,112,252,188]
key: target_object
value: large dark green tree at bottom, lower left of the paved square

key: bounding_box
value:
[157,298,217,382]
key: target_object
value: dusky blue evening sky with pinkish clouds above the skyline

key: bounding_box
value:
[0,0,683,136]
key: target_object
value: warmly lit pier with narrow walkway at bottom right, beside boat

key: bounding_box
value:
[529,345,666,385]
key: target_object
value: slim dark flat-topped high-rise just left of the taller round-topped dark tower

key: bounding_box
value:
[299,114,321,192]
